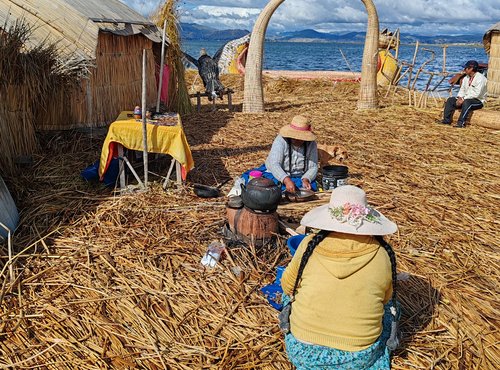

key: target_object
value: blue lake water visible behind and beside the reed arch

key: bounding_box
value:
[182,41,488,92]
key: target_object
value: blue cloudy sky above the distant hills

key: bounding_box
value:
[120,0,500,36]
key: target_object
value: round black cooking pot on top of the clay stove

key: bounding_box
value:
[241,177,281,211]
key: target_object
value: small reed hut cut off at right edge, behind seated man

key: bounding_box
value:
[483,22,500,98]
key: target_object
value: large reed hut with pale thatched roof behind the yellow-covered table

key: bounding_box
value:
[0,0,166,129]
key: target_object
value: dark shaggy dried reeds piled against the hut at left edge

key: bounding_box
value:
[0,19,81,172]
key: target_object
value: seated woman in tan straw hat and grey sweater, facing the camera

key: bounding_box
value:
[228,115,318,202]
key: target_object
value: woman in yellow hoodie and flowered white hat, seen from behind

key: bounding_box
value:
[280,185,398,370]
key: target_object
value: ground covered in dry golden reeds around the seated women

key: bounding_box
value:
[0,72,500,370]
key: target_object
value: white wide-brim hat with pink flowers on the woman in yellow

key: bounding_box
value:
[300,185,398,235]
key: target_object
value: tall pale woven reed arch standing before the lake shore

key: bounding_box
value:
[243,0,379,113]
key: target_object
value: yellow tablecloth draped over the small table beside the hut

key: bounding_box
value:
[99,111,194,184]
